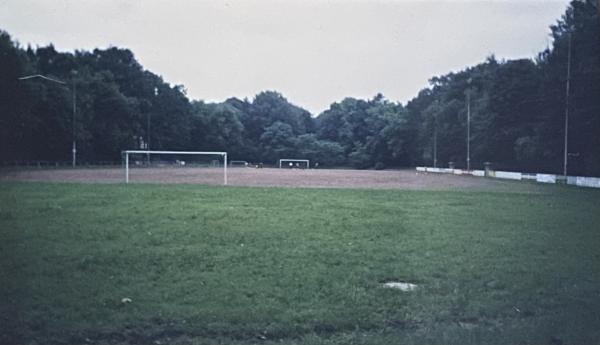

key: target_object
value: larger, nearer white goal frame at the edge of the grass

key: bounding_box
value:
[123,150,227,185]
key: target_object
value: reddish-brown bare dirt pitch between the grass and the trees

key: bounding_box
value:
[0,167,540,192]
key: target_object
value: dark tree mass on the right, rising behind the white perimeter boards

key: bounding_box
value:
[406,0,600,176]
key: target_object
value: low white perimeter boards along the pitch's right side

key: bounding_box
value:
[417,167,600,188]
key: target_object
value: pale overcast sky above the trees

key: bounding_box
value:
[0,0,568,115]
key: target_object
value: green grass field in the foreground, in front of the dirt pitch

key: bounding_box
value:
[0,183,600,344]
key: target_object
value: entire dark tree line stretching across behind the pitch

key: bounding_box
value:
[0,0,600,176]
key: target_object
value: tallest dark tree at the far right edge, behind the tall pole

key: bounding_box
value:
[537,0,600,175]
